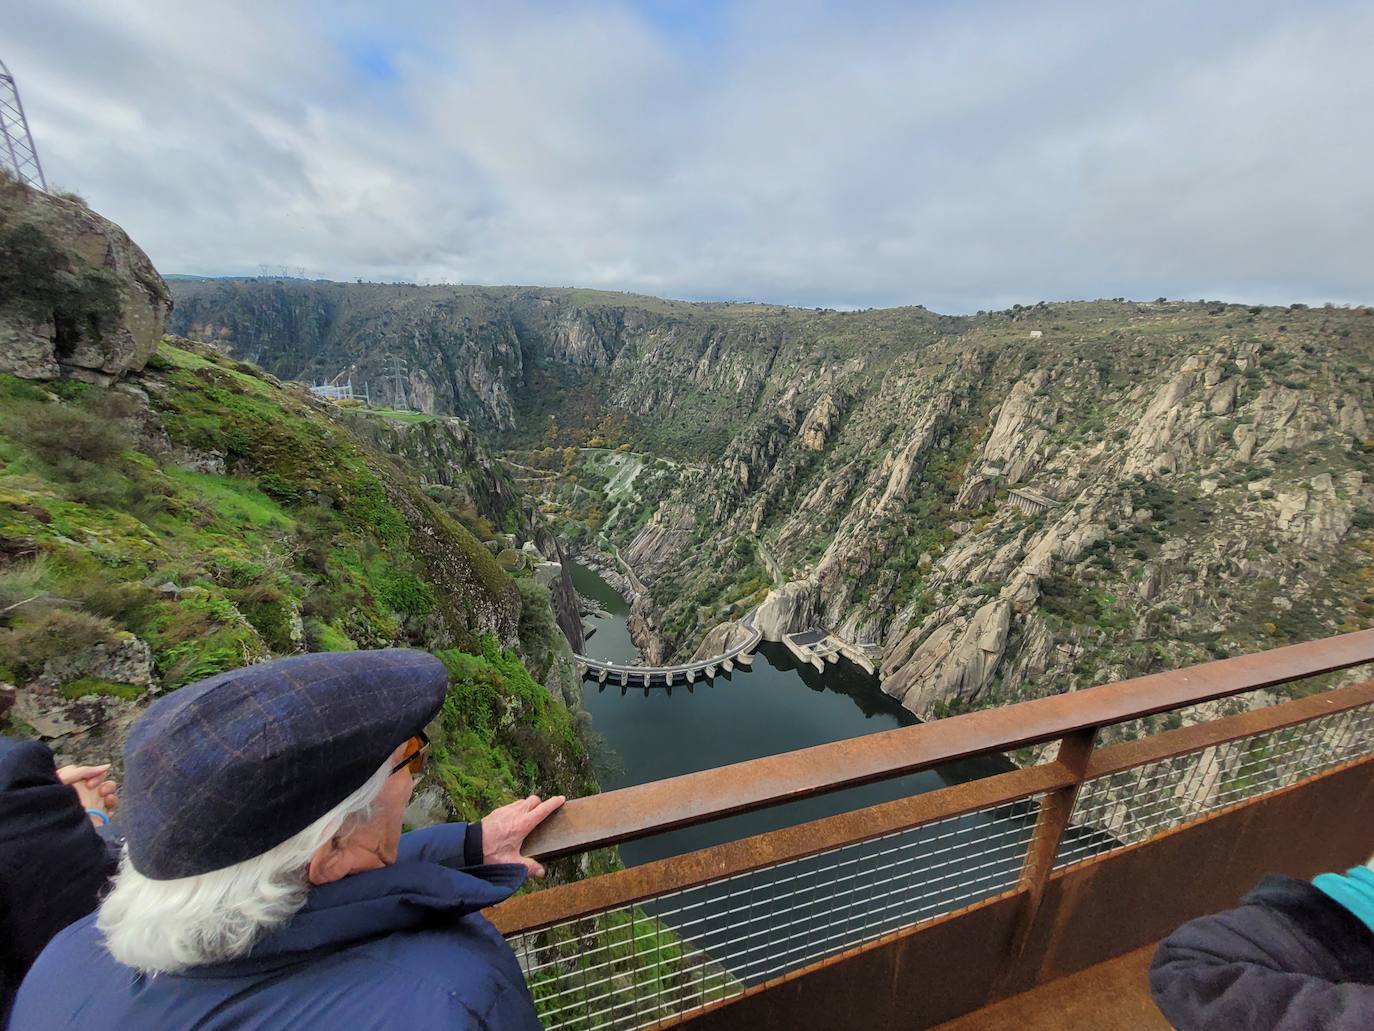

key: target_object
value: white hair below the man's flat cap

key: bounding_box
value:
[96,759,392,973]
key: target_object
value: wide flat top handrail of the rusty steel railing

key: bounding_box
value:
[528,630,1374,859]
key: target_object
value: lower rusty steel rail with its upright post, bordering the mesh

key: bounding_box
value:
[486,680,1374,949]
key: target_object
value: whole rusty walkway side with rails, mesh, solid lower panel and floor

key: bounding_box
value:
[486,630,1374,1031]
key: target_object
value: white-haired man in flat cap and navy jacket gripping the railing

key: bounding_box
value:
[11,649,563,1031]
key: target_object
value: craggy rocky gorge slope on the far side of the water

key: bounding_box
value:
[166,285,1374,742]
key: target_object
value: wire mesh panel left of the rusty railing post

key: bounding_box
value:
[511,799,1039,1031]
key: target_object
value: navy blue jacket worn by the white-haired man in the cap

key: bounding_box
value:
[11,823,539,1031]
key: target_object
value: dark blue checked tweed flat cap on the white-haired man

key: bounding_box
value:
[120,647,448,881]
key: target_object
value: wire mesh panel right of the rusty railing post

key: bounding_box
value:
[1055,705,1374,869]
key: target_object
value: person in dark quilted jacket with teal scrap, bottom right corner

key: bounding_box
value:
[1150,859,1374,1031]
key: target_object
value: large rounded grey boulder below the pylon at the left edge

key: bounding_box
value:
[0,177,172,385]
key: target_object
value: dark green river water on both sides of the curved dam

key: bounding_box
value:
[570,564,1009,866]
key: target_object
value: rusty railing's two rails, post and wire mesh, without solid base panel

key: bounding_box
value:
[491,631,1374,1031]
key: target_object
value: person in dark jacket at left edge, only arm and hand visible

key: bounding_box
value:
[0,738,118,1027]
